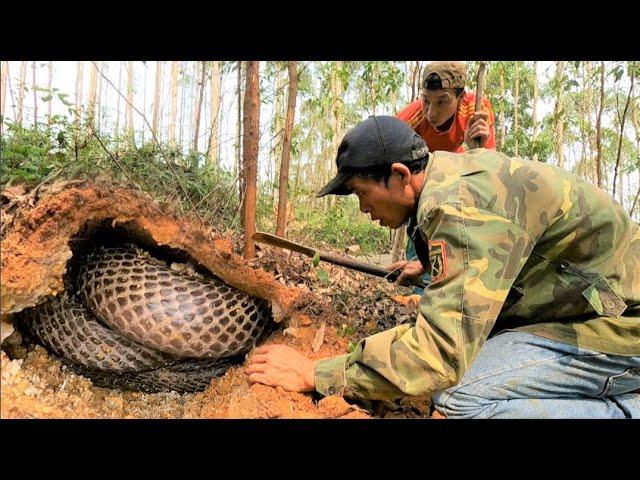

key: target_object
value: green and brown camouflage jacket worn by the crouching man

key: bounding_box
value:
[316,149,640,400]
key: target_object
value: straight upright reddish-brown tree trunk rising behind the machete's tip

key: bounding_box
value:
[242,62,260,259]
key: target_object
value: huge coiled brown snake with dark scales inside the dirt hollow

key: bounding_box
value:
[20,245,273,392]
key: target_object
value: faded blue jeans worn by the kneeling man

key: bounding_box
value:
[432,331,640,418]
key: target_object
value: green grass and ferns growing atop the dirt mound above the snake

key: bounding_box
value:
[0,116,239,230]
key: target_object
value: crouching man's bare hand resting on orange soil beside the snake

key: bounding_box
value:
[245,345,317,392]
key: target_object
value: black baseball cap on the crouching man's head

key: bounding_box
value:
[317,115,429,197]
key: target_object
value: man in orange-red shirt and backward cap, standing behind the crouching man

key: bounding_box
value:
[396,62,496,153]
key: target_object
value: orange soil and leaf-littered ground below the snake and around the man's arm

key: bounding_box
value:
[0,230,430,419]
